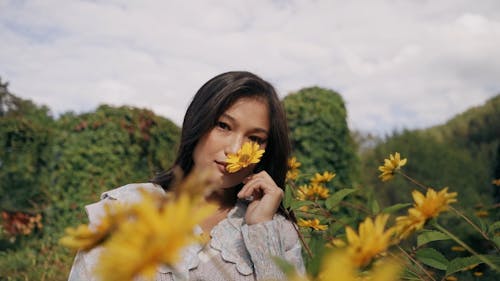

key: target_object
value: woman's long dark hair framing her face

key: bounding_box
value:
[151,71,290,195]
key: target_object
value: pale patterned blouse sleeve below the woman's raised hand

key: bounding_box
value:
[242,215,305,280]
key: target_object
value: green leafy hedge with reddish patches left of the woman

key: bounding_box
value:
[0,78,180,280]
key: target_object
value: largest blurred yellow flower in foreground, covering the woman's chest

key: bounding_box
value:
[96,192,215,281]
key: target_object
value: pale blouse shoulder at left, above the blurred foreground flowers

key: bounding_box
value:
[85,183,165,224]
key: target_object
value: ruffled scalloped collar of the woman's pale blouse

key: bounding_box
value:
[158,201,253,279]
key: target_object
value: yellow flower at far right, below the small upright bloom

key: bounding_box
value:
[396,187,457,239]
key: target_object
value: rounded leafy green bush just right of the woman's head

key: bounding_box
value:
[283,87,358,186]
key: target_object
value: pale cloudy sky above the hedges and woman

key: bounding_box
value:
[0,0,500,135]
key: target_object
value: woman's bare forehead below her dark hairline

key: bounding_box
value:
[222,97,270,131]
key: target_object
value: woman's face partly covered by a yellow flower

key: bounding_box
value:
[193,97,270,188]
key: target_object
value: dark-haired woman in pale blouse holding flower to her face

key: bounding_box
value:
[70,72,304,280]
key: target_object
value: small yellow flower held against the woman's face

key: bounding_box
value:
[226,142,264,173]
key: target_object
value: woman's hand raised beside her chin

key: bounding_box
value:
[238,171,284,225]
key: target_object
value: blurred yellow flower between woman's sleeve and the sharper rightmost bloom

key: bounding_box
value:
[346,214,394,267]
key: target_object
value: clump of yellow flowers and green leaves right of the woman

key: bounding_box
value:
[285,153,500,281]
